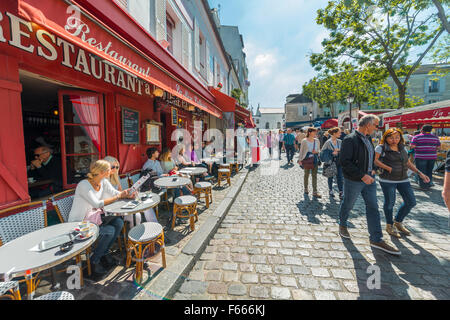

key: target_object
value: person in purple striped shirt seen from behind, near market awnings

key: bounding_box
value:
[411,125,441,190]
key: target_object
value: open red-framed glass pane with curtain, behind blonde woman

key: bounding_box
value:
[58,90,105,189]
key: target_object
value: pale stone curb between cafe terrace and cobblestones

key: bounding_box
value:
[133,167,250,300]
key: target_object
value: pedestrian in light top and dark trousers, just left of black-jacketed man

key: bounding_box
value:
[321,127,344,200]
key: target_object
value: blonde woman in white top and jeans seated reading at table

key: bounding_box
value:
[69,160,134,277]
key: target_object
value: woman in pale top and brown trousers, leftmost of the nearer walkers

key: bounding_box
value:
[298,127,322,198]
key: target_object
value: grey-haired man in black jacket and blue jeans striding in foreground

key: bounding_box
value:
[339,115,400,255]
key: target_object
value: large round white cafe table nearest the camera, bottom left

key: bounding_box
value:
[0,222,99,299]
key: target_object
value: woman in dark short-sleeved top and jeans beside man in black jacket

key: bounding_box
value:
[375,128,430,238]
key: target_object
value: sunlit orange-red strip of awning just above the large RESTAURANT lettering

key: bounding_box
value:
[19,0,222,118]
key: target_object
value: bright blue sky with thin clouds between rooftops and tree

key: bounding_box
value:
[209,0,328,114]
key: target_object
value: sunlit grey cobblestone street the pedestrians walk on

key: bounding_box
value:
[174,150,450,300]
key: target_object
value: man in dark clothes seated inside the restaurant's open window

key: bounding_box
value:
[28,146,63,198]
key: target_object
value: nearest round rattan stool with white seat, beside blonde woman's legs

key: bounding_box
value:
[126,222,166,283]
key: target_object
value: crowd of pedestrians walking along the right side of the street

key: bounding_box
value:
[255,115,450,255]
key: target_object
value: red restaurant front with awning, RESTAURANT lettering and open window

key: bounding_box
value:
[0,0,221,209]
